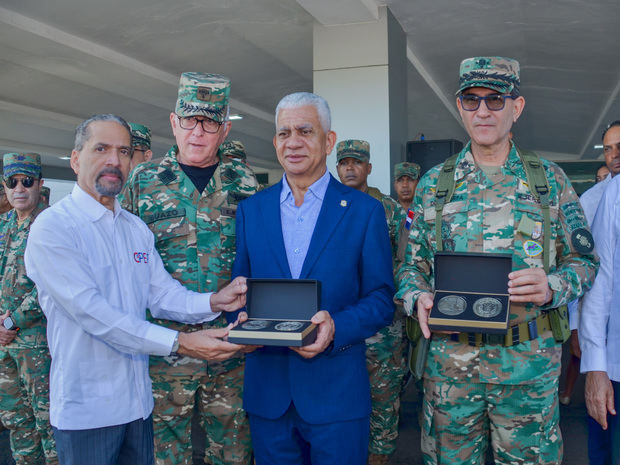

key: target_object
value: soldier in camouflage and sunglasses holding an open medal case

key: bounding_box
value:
[396,57,598,465]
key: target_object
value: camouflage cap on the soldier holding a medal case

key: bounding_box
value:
[457,57,520,94]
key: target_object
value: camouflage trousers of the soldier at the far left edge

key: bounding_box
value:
[0,347,58,465]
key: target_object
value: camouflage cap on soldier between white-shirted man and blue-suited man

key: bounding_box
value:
[175,73,230,123]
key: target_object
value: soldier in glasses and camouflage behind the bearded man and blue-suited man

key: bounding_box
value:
[120,73,258,465]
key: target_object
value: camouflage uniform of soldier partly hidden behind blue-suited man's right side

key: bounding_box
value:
[366,187,408,455]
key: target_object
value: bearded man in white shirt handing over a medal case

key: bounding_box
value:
[25,115,247,465]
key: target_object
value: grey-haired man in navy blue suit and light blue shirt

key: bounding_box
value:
[233,92,394,465]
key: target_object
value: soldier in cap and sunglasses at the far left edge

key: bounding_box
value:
[0,153,58,465]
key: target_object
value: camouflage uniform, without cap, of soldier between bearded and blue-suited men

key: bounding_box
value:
[119,146,257,465]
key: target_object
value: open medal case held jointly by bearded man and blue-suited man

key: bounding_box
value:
[228,278,321,347]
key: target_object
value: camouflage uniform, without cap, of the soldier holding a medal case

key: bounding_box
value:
[396,144,597,464]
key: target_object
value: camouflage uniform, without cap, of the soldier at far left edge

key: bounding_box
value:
[0,203,58,465]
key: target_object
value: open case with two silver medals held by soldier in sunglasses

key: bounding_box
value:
[428,252,512,334]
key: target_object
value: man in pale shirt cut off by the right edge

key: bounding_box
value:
[579,121,620,465]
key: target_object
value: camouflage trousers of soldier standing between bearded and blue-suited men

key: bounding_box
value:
[150,362,252,465]
